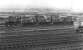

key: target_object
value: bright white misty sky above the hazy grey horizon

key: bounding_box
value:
[0,0,83,12]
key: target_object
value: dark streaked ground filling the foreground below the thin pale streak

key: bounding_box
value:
[0,25,83,50]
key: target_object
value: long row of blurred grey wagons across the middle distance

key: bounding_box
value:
[2,15,73,26]
